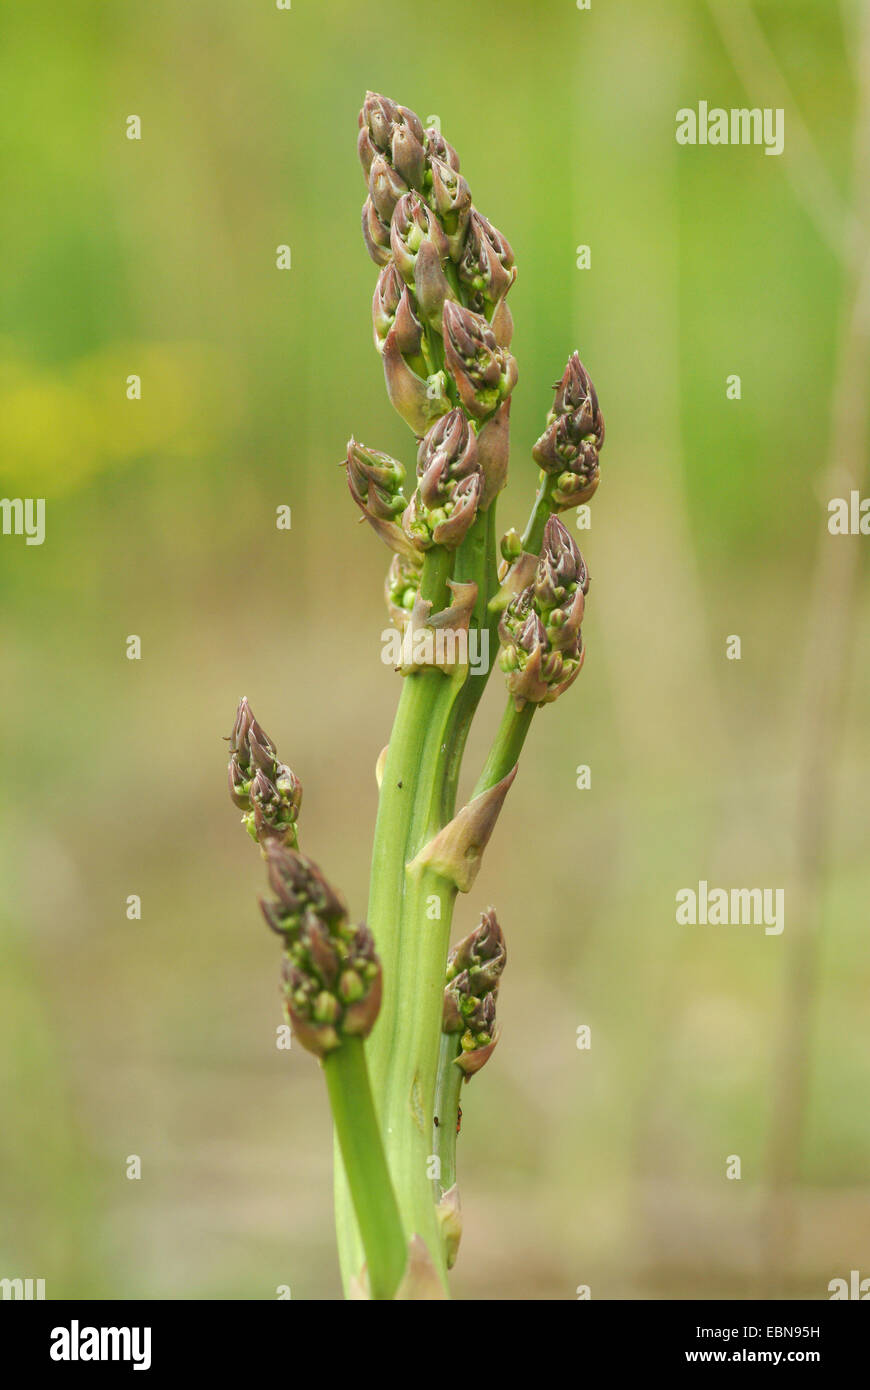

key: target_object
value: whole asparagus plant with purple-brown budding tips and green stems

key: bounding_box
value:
[223,92,605,1298]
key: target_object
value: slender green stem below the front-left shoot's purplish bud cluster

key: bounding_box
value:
[324,1038,407,1298]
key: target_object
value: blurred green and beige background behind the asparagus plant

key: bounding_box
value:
[0,0,870,1298]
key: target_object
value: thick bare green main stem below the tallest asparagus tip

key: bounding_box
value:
[336,425,550,1287]
